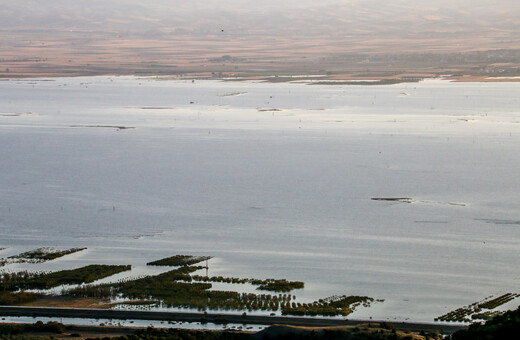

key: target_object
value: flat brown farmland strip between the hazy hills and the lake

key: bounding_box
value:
[0,30,520,81]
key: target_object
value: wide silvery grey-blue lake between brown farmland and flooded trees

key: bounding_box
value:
[0,76,520,321]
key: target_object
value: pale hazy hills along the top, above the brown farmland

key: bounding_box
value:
[4,0,520,49]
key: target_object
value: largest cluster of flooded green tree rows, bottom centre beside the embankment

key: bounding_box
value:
[65,266,373,316]
